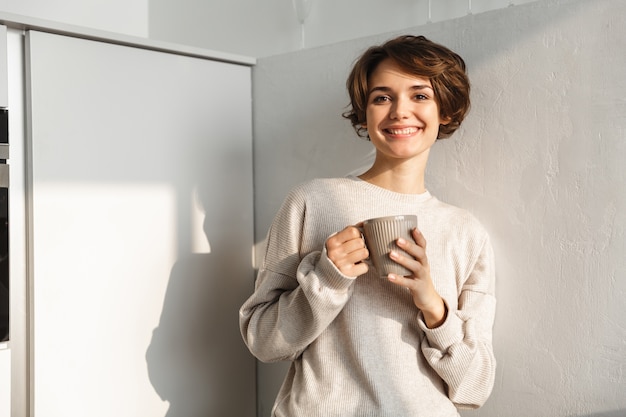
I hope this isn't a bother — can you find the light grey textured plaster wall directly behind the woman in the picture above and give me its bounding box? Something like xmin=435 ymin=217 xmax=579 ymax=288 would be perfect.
xmin=253 ymin=0 xmax=626 ymax=417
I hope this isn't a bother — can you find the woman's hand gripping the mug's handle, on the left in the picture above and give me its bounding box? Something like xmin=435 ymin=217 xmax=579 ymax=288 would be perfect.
xmin=326 ymin=224 xmax=369 ymax=277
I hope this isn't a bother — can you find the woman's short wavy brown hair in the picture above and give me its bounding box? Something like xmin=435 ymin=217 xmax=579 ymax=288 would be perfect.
xmin=343 ymin=35 xmax=470 ymax=139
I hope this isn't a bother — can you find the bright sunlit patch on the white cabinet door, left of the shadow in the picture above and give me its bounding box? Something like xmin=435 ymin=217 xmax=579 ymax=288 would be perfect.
xmin=32 ymin=183 xmax=177 ymax=415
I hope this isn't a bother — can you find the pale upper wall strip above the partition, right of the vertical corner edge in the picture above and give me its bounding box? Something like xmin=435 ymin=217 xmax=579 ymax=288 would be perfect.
xmin=150 ymin=0 xmax=533 ymax=57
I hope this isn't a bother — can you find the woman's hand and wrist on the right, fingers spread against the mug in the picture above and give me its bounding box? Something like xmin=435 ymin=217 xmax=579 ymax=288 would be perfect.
xmin=387 ymin=228 xmax=448 ymax=329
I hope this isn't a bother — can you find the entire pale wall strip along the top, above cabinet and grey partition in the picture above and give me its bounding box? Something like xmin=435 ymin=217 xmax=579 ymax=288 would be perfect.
xmin=0 ymin=0 xmax=535 ymax=57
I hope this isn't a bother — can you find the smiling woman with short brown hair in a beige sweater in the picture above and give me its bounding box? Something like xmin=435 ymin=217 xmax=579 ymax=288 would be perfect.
xmin=240 ymin=36 xmax=495 ymax=417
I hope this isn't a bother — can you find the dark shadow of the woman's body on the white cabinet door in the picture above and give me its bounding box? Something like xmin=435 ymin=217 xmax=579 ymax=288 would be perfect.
xmin=146 ymin=253 xmax=254 ymax=417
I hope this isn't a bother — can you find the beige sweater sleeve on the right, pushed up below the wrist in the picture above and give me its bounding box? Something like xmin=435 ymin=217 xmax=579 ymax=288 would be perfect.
xmin=419 ymin=232 xmax=496 ymax=408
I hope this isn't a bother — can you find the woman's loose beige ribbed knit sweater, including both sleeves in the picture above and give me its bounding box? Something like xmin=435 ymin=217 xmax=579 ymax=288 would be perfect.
xmin=240 ymin=177 xmax=496 ymax=417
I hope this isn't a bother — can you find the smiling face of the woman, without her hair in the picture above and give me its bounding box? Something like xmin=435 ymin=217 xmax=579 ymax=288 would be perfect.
xmin=365 ymin=59 xmax=445 ymax=161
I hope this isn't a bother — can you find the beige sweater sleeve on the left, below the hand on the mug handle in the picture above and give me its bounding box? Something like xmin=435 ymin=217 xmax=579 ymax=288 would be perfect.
xmin=239 ymin=187 xmax=354 ymax=362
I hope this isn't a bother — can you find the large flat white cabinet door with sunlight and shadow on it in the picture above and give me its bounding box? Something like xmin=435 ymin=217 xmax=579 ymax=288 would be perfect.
xmin=26 ymin=32 xmax=255 ymax=417
